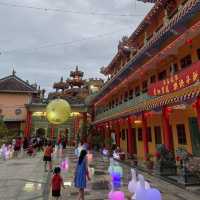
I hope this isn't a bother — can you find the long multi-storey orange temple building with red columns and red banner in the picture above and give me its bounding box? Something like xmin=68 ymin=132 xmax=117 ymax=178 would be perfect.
xmin=90 ymin=0 xmax=200 ymax=160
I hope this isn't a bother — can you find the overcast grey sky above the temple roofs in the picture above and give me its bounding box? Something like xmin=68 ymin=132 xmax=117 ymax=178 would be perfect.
xmin=0 ymin=0 xmax=152 ymax=91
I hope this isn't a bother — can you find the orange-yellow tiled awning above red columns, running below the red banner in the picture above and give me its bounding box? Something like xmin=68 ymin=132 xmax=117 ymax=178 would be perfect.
xmin=94 ymin=82 xmax=200 ymax=124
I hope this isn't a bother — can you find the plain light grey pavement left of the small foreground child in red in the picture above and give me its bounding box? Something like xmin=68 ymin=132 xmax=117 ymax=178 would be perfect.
xmin=0 ymin=153 xmax=50 ymax=200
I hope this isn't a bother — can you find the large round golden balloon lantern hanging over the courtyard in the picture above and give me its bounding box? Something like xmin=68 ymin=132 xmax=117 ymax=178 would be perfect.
xmin=46 ymin=99 xmax=71 ymax=124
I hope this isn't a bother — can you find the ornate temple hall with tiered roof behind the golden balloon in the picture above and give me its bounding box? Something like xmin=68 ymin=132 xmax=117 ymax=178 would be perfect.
xmin=27 ymin=66 xmax=104 ymax=142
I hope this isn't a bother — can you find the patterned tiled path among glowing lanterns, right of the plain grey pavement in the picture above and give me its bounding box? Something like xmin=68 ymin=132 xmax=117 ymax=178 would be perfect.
xmin=50 ymin=148 xmax=200 ymax=200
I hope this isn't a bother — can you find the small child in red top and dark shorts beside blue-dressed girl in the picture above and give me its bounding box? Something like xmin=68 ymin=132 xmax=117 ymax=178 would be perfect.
xmin=51 ymin=167 xmax=65 ymax=200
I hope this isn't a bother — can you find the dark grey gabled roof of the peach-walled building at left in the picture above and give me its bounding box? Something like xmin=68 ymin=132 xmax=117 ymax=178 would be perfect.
xmin=0 ymin=70 xmax=38 ymax=93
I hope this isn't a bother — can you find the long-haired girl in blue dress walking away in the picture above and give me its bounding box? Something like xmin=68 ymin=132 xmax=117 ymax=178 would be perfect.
xmin=74 ymin=150 xmax=90 ymax=200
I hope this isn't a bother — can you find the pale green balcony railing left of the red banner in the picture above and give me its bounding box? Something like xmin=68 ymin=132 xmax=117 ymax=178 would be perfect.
xmin=96 ymin=93 xmax=151 ymax=120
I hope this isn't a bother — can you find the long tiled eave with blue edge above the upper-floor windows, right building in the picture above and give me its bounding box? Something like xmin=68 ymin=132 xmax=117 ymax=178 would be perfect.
xmin=95 ymin=0 xmax=200 ymax=105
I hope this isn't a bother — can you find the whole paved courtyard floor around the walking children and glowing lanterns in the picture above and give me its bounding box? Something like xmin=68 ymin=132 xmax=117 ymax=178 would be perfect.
xmin=0 ymin=148 xmax=199 ymax=200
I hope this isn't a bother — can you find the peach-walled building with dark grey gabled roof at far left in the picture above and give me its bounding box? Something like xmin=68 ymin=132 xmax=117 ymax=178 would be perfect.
xmin=0 ymin=70 xmax=44 ymax=135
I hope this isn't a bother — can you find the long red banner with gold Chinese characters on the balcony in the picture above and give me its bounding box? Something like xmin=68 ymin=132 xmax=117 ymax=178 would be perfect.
xmin=148 ymin=61 xmax=200 ymax=96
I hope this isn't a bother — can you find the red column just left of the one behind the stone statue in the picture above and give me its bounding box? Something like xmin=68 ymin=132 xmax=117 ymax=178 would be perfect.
xmin=142 ymin=113 xmax=149 ymax=159
